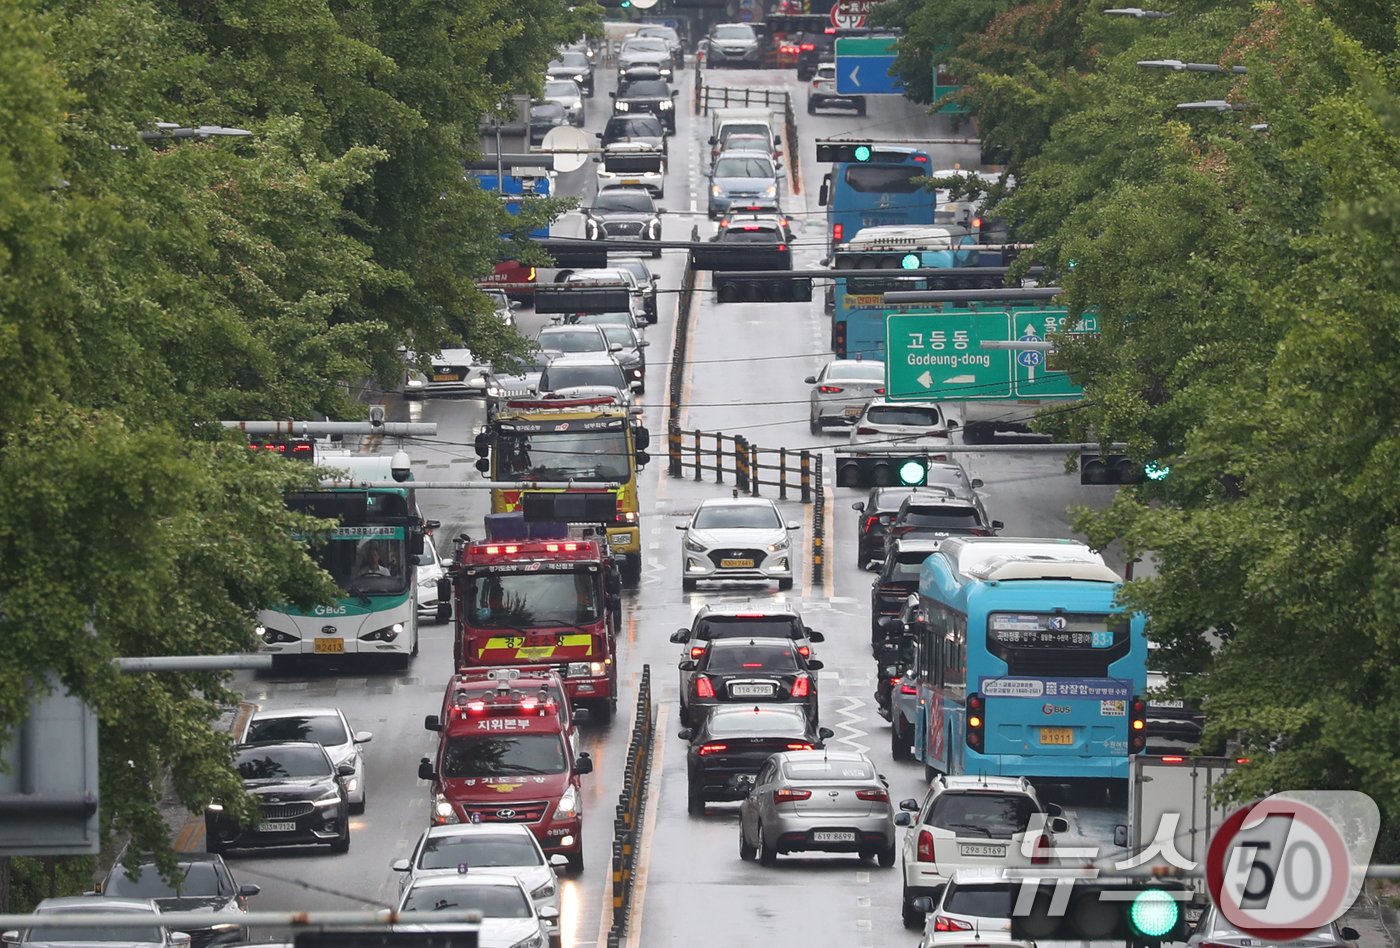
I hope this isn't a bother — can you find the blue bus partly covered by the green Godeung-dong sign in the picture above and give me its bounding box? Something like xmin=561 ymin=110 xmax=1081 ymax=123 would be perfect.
xmin=830 ymin=224 xmax=1000 ymax=360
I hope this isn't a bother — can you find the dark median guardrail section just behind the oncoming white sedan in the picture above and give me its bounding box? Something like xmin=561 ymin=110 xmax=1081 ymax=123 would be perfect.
xmin=666 ymin=424 xmax=822 ymax=504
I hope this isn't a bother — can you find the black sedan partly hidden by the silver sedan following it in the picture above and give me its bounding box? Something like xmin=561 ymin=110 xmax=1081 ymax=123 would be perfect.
xmin=676 ymin=704 xmax=832 ymax=816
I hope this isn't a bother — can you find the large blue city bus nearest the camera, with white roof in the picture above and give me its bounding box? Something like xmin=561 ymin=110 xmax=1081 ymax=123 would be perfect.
xmin=890 ymin=536 xmax=1148 ymax=795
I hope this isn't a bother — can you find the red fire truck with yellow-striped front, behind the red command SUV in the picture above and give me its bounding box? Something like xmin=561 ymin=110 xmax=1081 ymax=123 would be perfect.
xmin=451 ymin=538 xmax=622 ymax=724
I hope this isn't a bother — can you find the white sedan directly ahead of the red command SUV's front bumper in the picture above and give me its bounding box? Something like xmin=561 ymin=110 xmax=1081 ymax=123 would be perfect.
xmin=389 ymin=823 xmax=568 ymax=940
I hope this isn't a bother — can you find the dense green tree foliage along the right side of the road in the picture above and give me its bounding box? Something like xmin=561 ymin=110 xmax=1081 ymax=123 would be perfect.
xmin=909 ymin=0 xmax=1400 ymax=816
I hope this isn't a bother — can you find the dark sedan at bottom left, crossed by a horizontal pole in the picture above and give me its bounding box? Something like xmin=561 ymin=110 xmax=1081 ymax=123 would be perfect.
xmin=98 ymin=853 xmax=262 ymax=948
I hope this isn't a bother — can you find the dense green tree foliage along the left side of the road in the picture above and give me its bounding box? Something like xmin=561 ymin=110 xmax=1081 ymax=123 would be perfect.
xmin=0 ymin=0 xmax=588 ymax=909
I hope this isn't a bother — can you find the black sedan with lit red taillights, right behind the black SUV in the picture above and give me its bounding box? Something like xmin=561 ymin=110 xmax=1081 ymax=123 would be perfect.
xmin=679 ymin=637 xmax=822 ymax=727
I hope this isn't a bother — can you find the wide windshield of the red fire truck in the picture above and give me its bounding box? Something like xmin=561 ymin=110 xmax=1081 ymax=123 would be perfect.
xmin=462 ymin=571 xmax=602 ymax=629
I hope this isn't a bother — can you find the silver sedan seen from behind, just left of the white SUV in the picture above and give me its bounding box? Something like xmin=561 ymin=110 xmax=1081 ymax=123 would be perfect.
xmin=739 ymin=751 xmax=895 ymax=868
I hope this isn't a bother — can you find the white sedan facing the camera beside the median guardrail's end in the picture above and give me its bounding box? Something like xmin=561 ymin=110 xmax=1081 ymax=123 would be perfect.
xmin=676 ymin=497 xmax=801 ymax=592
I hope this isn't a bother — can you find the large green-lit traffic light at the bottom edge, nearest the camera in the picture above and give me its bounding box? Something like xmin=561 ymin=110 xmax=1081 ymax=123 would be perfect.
xmin=1011 ymin=878 xmax=1191 ymax=948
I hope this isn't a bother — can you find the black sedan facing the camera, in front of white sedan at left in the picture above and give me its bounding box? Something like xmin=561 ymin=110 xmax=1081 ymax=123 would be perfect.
xmin=204 ymin=741 xmax=354 ymax=853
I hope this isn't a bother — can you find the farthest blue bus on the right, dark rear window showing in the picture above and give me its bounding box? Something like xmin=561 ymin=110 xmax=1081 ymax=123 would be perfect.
xmin=819 ymin=144 xmax=937 ymax=255
